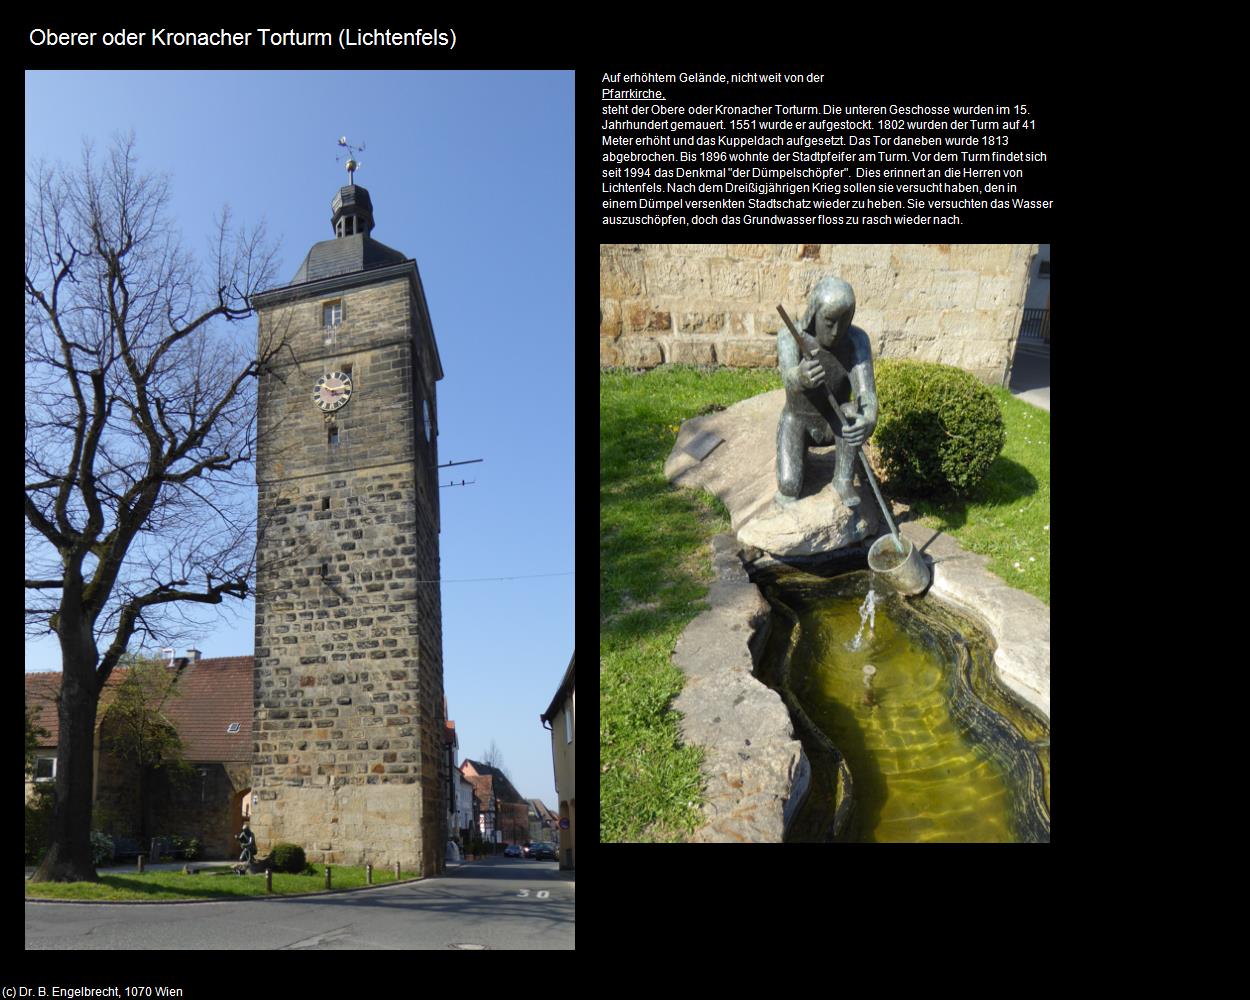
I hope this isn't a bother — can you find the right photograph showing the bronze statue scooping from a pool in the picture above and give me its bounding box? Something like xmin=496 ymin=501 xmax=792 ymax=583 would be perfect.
xmin=599 ymin=244 xmax=1050 ymax=844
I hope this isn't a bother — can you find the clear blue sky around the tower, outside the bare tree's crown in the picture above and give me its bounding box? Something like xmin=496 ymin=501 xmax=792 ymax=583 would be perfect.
xmin=25 ymin=71 xmax=575 ymax=809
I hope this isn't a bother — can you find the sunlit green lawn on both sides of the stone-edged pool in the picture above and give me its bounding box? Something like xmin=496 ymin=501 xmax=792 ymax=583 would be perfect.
xmin=599 ymin=366 xmax=1050 ymax=843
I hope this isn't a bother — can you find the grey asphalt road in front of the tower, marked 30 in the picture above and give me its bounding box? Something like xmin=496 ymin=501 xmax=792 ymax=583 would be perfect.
xmin=26 ymin=858 xmax=574 ymax=951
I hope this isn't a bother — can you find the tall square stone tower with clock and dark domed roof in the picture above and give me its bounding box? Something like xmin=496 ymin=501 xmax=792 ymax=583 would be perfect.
xmin=253 ymin=184 xmax=446 ymax=875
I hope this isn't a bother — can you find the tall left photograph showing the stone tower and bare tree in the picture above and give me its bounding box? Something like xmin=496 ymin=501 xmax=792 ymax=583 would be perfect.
xmin=25 ymin=71 xmax=576 ymax=949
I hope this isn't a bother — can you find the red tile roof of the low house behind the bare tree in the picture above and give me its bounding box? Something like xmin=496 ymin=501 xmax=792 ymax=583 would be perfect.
xmin=26 ymin=656 xmax=253 ymax=763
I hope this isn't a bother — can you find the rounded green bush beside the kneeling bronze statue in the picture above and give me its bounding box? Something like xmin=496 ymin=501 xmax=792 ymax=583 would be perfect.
xmin=873 ymin=359 xmax=1006 ymax=498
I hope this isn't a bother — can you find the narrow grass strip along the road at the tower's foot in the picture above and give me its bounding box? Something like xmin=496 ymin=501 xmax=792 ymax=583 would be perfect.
xmin=26 ymin=865 xmax=420 ymax=903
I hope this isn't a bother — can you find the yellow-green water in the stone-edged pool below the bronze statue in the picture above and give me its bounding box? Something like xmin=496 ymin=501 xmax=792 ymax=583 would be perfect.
xmin=765 ymin=573 xmax=1050 ymax=844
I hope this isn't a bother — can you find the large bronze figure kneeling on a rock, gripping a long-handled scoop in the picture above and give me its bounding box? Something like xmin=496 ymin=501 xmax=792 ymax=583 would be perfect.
xmin=776 ymin=278 xmax=876 ymax=508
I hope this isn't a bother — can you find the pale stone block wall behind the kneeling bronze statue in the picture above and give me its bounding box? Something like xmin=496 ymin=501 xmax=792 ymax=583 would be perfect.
xmin=599 ymin=244 xmax=1038 ymax=385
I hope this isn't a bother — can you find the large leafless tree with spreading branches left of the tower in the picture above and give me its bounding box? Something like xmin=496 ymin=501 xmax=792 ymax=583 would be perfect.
xmin=25 ymin=135 xmax=283 ymax=881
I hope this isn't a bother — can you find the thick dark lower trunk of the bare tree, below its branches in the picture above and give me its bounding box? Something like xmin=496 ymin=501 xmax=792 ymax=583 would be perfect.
xmin=31 ymin=658 xmax=100 ymax=883
